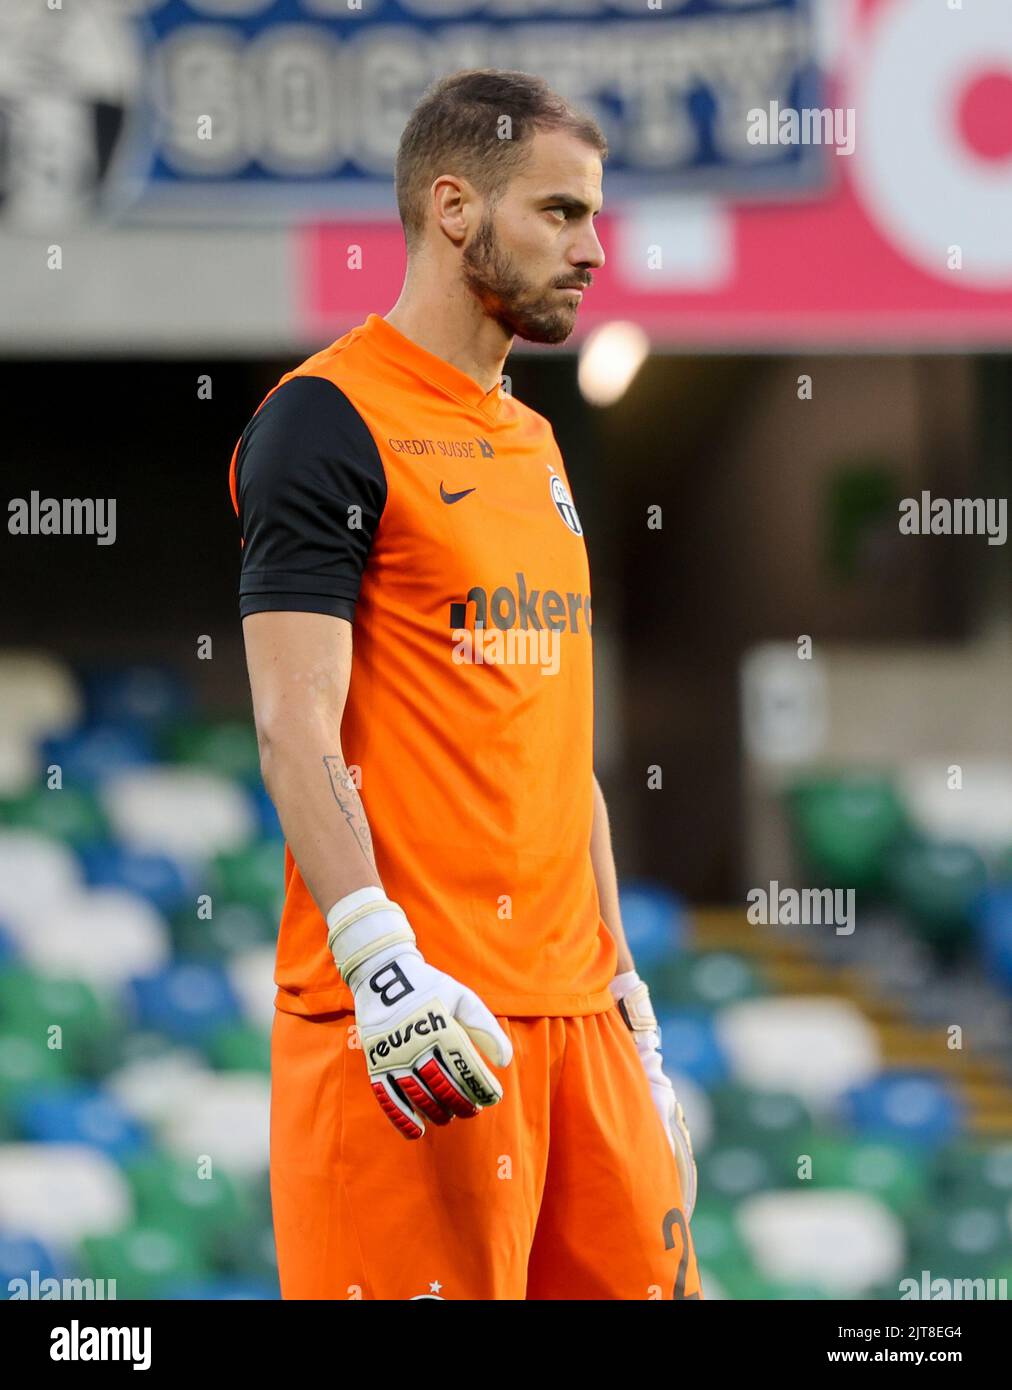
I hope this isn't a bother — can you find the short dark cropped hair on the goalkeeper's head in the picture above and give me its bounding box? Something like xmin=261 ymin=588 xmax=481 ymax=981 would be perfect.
xmin=395 ymin=68 xmax=607 ymax=252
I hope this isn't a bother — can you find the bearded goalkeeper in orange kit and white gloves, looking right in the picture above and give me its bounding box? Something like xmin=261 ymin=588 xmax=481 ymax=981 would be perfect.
xmin=231 ymin=70 xmax=702 ymax=1300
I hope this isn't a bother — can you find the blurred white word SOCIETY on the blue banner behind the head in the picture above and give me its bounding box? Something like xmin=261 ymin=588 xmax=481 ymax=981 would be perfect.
xmin=154 ymin=13 xmax=812 ymax=178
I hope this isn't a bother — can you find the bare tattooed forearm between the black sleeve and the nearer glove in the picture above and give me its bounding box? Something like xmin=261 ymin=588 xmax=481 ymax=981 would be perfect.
xmin=242 ymin=613 xmax=382 ymax=916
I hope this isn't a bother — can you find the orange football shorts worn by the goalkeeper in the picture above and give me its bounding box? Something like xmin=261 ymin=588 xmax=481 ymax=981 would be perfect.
xmin=271 ymin=1008 xmax=702 ymax=1300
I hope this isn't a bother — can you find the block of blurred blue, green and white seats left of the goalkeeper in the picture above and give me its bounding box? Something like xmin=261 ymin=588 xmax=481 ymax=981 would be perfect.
xmin=0 ymin=655 xmax=284 ymax=1298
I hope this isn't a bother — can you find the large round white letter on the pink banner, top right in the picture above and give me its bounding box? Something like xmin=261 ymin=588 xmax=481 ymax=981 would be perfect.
xmin=848 ymin=0 xmax=1012 ymax=289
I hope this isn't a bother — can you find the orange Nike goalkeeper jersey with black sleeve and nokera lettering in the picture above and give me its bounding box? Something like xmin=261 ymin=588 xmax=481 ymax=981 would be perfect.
xmin=229 ymin=314 xmax=616 ymax=1016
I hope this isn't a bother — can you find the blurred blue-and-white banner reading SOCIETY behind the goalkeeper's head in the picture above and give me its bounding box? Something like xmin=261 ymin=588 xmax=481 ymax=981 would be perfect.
xmin=0 ymin=0 xmax=824 ymax=221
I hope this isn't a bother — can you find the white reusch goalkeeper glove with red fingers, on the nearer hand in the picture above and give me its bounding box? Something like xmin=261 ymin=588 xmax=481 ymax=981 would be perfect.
xmin=327 ymin=884 xmax=513 ymax=1138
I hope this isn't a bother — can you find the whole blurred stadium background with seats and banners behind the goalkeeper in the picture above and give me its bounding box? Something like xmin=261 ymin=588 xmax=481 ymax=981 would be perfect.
xmin=0 ymin=0 xmax=1012 ymax=1298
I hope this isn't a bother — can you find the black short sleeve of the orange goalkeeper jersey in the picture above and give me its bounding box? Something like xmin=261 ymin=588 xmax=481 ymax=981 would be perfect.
xmin=235 ymin=377 xmax=386 ymax=621
